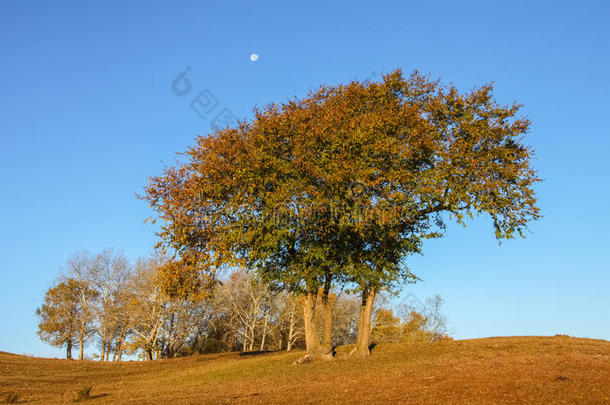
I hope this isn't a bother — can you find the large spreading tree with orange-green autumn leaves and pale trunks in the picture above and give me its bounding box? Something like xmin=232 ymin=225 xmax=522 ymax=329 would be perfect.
xmin=143 ymin=70 xmax=539 ymax=358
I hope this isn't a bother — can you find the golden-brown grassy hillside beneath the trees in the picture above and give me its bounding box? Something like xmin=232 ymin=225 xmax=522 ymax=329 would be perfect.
xmin=0 ymin=336 xmax=610 ymax=405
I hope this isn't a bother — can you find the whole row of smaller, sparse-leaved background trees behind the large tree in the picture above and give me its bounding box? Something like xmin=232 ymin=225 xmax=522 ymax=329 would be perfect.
xmin=36 ymin=249 xmax=445 ymax=361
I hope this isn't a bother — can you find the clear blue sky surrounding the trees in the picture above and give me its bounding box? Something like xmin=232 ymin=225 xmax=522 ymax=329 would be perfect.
xmin=0 ymin=1 xmax=610 ymax=356
